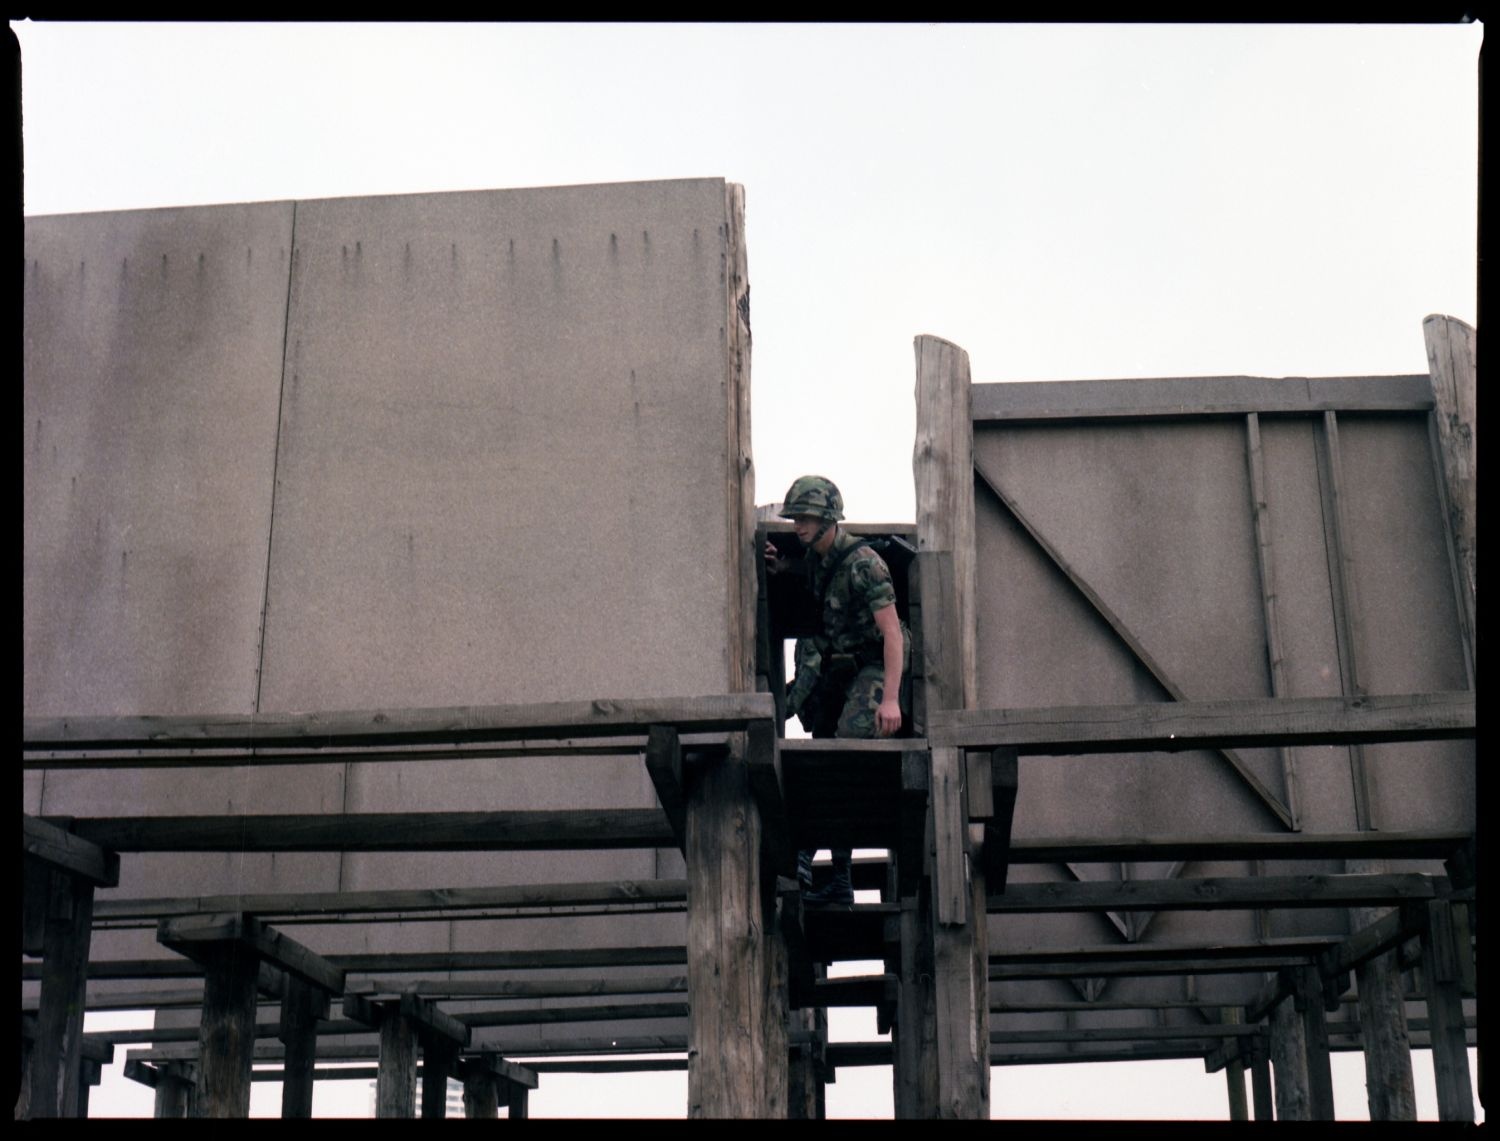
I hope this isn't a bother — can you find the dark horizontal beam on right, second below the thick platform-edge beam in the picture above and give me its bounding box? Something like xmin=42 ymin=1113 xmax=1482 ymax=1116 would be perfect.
xmin=989 ymin=873 xmax=1446 ymax=911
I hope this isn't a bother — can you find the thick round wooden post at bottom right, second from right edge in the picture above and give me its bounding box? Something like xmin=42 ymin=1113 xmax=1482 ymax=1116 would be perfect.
xmin=1344 ymin=859 xmax=1416 ymax=1122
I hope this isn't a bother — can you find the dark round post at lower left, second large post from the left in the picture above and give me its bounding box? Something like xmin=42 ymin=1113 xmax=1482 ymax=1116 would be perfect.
xmin=197 ymin=942 xmax=261 ymax=1117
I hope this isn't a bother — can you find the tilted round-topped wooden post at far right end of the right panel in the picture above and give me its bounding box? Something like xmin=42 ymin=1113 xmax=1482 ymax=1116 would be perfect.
xmin=1422 ymin=313 xmax=1479 ymax=658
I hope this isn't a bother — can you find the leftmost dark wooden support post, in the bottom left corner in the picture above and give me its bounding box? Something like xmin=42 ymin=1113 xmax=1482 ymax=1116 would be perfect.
xmin=26 ymin=871 xmax=95 ymax=1117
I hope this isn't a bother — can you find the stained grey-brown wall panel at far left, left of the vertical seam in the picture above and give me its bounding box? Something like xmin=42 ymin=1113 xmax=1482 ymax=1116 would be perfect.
xmin=23 ymin=202 xmax=293 ymax=717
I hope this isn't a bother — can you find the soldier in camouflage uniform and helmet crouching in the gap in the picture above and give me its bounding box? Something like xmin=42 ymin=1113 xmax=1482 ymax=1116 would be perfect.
xmin=765 ymin=475 xmax=911 ymax=904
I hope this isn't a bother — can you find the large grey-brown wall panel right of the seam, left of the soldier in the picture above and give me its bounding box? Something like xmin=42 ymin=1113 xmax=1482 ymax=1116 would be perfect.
xmin=263 ymin=180 xmax=729 ymax=709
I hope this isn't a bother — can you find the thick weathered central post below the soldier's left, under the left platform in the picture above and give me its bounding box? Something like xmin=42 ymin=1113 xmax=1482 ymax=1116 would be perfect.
xmin=686 ymin=733 xmax=783 ymax=1117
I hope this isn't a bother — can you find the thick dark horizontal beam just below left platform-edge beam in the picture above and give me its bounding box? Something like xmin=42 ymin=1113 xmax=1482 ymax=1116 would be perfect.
xmin=75 ymin=808 xmax=675 ymax=852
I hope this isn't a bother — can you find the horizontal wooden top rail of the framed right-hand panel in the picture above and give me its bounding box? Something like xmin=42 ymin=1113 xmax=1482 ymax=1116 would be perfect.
xmin=974 ymin=376 xmax=1433 ymax=423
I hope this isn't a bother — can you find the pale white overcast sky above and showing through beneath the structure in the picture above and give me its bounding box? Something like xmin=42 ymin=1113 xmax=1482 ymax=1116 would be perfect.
xmin=20 ymin=24 xmax=1484 ymax=1117
